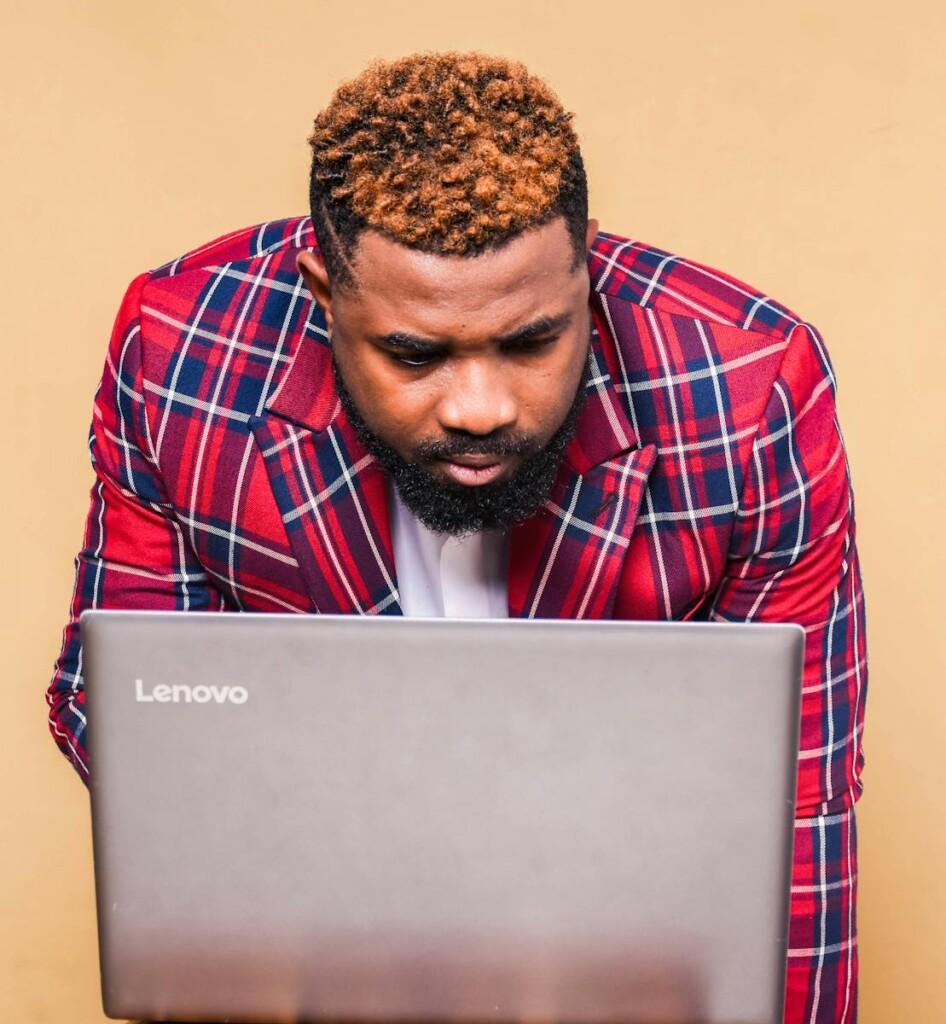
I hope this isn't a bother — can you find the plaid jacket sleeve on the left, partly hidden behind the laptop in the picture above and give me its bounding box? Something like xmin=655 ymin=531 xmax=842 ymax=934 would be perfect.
xmin=46 ymin=274 xmax=223 ymax=781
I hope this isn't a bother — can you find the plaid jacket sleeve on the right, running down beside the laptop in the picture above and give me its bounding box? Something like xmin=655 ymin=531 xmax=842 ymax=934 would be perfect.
xmin=711 ymin=324 xmax=867 ymax=1024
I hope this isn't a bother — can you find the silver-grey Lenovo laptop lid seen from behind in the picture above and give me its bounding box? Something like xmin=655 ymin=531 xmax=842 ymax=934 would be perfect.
xmin=81 ymin=611 xmax=804 ymax=1024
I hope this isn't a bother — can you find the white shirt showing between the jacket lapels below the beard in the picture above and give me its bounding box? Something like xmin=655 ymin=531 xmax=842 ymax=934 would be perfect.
xmin=388 ymin=480 xmax=509 ymax=618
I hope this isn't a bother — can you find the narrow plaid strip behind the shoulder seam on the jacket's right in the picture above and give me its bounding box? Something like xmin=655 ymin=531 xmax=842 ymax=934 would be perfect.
xmin=589 ymin=231 xmax=802 ymax=338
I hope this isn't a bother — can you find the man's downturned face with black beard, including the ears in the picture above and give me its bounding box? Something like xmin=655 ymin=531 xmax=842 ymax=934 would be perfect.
xmin=299 ymin=218 xmax=597 ymax=534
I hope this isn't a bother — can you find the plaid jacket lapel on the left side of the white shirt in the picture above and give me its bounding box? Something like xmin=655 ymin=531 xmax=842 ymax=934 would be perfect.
xmin=250 ymin=315 xmax=400 ymax=614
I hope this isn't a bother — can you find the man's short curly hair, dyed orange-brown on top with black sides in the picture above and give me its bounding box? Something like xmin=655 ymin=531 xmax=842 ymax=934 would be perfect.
xmin=309 ymin=52 xmax=588 ymax=287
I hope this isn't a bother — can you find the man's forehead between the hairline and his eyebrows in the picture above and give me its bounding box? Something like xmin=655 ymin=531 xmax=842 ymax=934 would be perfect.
xmin=334 ymin=218 xmax=587 ymax=338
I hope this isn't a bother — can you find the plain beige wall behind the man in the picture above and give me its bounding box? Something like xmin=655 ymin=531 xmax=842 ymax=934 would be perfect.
xmin=0 ymin=0 xmax=946 ymax=1024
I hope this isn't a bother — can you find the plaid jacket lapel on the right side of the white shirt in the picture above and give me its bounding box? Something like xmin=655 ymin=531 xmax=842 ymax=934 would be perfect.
xmin=509 ymin=308 xmax=657 ymax=618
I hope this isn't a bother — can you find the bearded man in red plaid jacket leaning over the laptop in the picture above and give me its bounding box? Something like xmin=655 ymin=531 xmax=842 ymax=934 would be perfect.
xmin=48 ymin=54 xmax=866 ymax=1022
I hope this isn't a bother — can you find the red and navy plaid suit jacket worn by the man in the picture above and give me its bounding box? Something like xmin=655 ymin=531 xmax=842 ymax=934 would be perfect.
xmin=48 ymin=218 xmax=866 ymax=1024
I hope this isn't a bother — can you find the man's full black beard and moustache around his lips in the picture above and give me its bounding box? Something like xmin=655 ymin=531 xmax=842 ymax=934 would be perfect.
xmin=332 ymin=352 xmax=590 ymax=536
